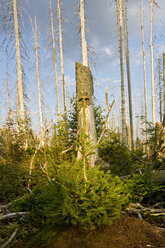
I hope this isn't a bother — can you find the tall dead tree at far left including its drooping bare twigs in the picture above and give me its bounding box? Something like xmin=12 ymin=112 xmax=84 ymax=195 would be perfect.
xmin=1 ymin=0 xmax=25 ymax=126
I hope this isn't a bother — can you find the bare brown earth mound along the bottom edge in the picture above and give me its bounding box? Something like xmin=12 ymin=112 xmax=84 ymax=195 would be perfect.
xmin=11 ymin=214 xmax=165 ymax=248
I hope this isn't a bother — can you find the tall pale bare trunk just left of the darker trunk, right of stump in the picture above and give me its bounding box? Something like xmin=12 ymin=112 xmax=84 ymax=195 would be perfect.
xmin=117 ymin=0 xmax=127 ymax=144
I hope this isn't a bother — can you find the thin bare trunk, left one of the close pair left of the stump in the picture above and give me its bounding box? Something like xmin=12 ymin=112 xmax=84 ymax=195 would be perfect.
xmin=49 ymin=0 xmax=60 ymax=116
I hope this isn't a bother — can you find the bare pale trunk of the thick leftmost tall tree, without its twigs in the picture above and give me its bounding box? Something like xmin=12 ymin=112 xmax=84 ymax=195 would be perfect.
xmin=12 ymin=0 xmax=25 ymax=123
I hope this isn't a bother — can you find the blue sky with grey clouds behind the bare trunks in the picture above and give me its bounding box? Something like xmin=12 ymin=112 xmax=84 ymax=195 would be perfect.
xmin=0 ymin=0 xmax=165 ymax=136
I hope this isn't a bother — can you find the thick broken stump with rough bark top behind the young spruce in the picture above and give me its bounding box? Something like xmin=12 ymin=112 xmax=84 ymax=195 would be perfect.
xmin=76 ymin=63 xmax=98 ymax=168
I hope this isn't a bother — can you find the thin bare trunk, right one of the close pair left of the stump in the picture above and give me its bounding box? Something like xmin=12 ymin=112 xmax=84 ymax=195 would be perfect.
xmin=57 ymin=0 xmax=66 ymax=113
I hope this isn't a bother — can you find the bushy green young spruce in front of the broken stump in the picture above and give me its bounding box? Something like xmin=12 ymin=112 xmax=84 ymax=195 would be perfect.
xmin=15 ymin=162 xmax=128 ymax=229
